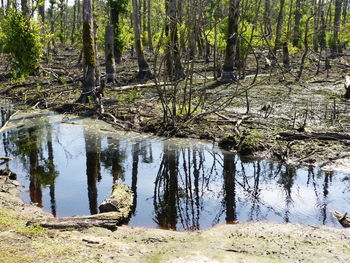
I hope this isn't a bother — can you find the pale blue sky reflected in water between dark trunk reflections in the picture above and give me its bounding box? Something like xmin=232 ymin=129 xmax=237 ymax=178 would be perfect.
xmin=0 ymin=109 xmax=350 ymax=229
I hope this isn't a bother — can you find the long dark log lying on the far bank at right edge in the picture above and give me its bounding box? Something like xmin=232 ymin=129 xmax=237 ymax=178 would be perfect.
xmin=278 ymin=132 xmax=350 ymax=141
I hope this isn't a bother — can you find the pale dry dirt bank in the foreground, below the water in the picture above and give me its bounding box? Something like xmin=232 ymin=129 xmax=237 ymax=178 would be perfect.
xmin=0 ymin=174 xmax=350 ymax=263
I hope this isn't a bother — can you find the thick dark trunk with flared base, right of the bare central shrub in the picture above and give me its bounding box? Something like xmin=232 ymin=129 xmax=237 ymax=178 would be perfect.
xmin=221 ymin=0 xmax=240 ymax=82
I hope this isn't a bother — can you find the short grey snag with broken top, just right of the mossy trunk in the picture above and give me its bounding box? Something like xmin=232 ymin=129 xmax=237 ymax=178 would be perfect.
xmin=105 ymin=25 xmax=115 ymax=83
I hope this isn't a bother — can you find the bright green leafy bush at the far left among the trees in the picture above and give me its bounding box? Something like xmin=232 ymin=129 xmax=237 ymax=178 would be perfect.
xmin=0 ymin=9 xmax=43 ymax=78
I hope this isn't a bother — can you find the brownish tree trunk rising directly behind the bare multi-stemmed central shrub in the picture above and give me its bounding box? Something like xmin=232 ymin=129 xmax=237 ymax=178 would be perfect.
xmin=165 ymin=0 xmax=185 ymax=79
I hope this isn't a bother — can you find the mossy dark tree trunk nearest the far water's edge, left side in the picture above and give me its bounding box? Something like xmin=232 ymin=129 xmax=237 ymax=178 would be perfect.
xmin=78 ymin=0 xmax=96 ymax=103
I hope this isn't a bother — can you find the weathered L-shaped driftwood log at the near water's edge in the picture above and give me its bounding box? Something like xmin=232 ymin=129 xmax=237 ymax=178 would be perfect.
xmin=27 ymin=182 xmax=133 ymax=230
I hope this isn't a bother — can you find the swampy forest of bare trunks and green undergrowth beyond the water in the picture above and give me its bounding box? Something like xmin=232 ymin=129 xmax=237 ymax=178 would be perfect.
xmin=0 ymin=0 xmax=350 ymax=159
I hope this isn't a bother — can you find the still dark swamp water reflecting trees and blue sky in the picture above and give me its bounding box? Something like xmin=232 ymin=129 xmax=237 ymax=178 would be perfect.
xmin=0 ymin=104 xmax=350 ymax=230
